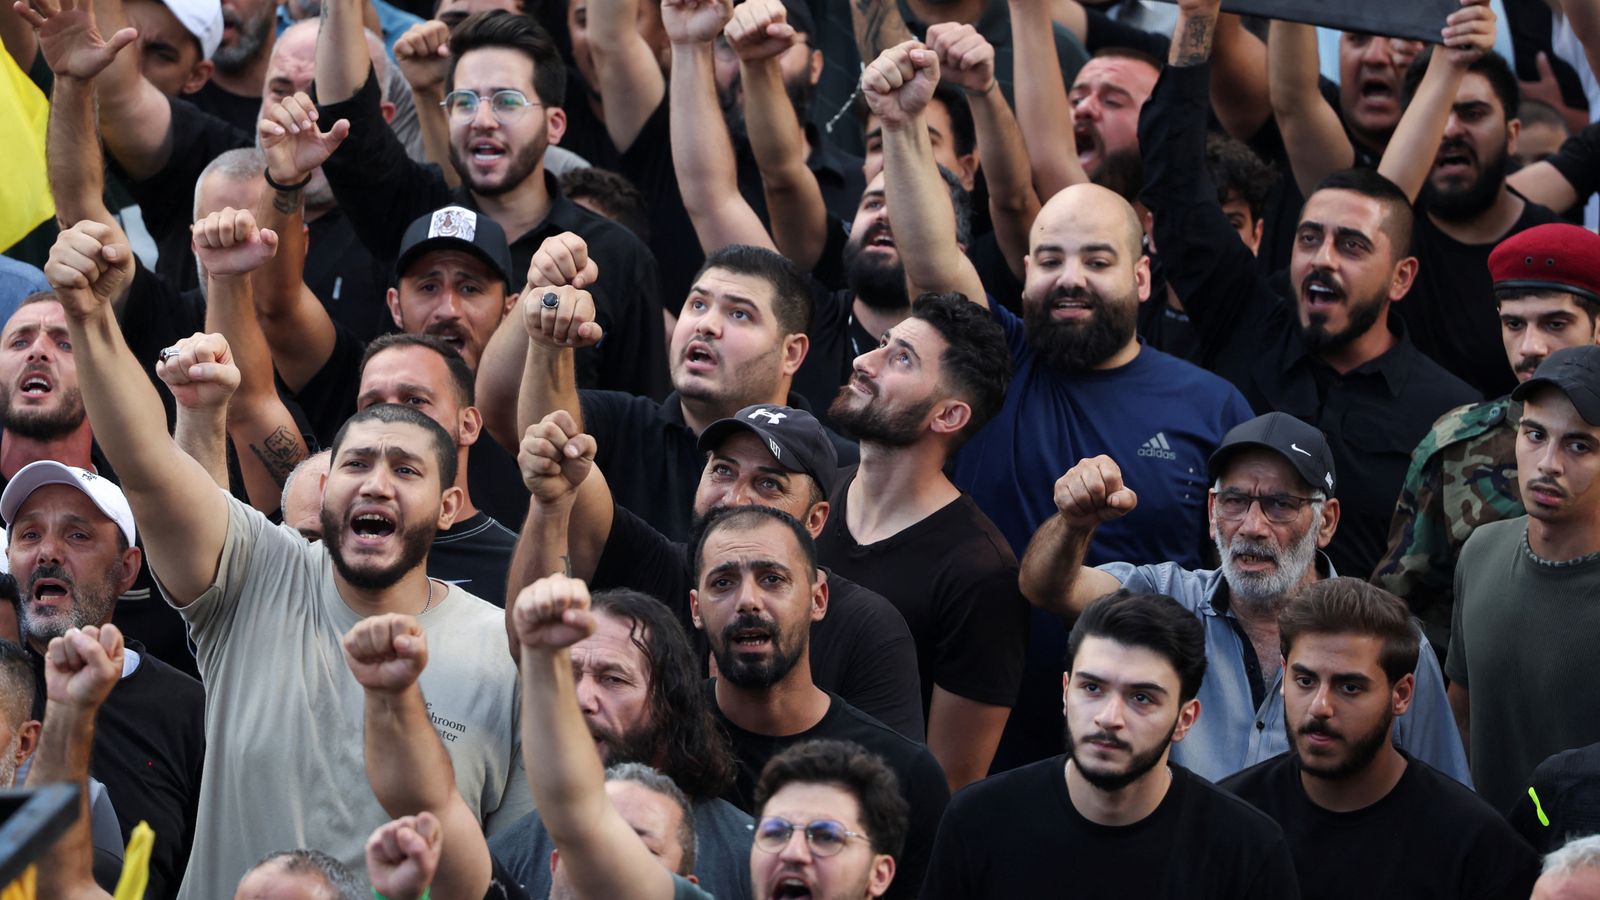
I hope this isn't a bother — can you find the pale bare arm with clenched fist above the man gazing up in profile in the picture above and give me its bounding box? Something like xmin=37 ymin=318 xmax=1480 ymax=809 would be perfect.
xmin=861 ymin=40 xmax=989 ymax=301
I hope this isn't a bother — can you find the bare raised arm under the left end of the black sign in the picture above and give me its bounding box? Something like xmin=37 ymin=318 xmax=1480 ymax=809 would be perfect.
xmin=1267 ymin=21 xmax=1356 ymax=195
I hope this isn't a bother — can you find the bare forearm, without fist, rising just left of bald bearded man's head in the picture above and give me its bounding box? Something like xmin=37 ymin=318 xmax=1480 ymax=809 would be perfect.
xmin=970 ymin=82 xmax=1040 ymax=279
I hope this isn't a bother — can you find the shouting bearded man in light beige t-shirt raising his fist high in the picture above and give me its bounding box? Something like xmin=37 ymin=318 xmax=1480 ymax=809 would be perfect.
xmin=45 ymin=212 xmax=530 ymax=897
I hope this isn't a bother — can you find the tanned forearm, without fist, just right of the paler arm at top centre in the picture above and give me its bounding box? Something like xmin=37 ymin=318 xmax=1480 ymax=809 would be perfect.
xmin=741 ymin=59 xmax=827 ymax=265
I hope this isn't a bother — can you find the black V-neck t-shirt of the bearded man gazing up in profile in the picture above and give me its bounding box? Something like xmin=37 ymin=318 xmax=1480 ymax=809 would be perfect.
xmin=816 ymin=472 xmax=1029 ymax=713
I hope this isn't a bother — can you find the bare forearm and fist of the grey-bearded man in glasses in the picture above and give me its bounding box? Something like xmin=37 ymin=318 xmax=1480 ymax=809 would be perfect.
xmin=1018 ymin=456 xmax=1139 ymax=617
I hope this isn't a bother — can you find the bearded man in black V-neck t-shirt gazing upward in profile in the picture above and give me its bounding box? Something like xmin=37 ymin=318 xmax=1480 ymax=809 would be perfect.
xmin=818 ymin=295 xmax=1029 ymax=788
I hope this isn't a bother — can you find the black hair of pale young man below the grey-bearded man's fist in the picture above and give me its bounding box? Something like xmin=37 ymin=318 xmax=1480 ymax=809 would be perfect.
xmin=1067 ymin=589 xmax=1205 ymax=703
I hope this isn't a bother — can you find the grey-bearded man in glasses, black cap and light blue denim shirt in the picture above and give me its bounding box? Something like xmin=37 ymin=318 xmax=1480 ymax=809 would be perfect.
xmin=1021 ymin=413 xmax=1467 ymax=783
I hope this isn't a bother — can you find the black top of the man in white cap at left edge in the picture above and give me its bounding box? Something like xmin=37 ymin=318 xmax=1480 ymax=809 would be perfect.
xmin=30 ymin=641 xmax=205 ymax=900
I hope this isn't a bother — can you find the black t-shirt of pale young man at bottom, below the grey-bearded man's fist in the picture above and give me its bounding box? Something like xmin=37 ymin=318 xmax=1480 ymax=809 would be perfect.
xmin=922 ymin=754 xmax=1299 ymax=900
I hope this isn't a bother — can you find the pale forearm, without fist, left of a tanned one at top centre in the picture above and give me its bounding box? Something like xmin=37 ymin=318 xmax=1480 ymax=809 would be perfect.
xmin=669 ymin=43 xmax=771 ymax=253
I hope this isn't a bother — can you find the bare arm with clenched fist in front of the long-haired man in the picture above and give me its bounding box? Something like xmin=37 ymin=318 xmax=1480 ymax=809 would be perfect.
xmin=507 ymin=575 xmax=675 ymax=900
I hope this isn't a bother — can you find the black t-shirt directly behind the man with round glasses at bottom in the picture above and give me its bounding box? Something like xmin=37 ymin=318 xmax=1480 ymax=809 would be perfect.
xmin=706 ymin=679 xmax=950 ymax=900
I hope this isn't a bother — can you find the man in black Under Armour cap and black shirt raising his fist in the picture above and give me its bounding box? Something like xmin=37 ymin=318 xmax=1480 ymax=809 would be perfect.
xmin=509 ymin=405 xmax=923 ymax=741
